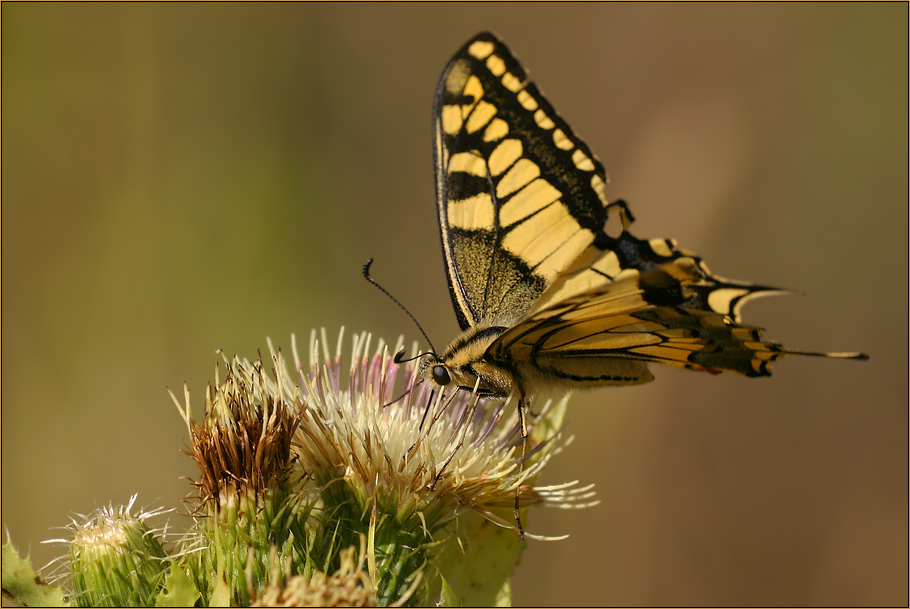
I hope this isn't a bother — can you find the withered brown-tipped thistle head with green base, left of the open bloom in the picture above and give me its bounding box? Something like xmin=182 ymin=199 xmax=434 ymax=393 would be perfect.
xmin=174 ymin=357 xmax=320 ymax=606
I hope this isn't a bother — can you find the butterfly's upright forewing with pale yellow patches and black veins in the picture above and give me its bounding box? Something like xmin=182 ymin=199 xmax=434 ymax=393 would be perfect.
xmin=433 ymin=33 xmax=607 ymax=329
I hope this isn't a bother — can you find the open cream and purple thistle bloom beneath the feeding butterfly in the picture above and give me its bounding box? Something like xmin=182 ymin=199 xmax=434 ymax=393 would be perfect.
xmin=284 ymin=332 xmax=593 ymax=535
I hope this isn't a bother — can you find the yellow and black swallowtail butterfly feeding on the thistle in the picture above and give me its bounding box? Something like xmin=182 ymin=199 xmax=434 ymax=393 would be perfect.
xmin=418 ymin=33 xmax=867 ymax=422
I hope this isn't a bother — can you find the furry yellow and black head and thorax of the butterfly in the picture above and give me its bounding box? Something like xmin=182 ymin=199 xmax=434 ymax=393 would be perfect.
xmin=419 ymin=324 xmax=516 ymax=398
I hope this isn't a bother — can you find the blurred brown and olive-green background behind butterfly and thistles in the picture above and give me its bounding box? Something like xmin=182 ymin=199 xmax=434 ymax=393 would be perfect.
xmin=0 ymin=3 xmax=908 ymax=605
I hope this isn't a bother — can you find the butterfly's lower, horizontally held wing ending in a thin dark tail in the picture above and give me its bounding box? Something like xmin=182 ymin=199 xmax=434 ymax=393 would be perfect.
xmin=486 ymin=256 xmax=865 ymax=386
